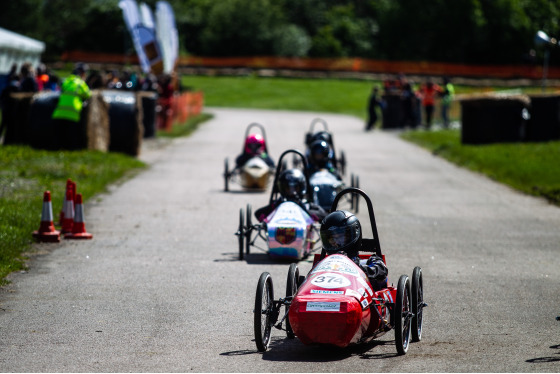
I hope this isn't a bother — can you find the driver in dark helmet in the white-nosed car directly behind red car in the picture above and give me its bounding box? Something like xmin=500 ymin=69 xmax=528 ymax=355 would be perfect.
xmin=255 ymin=169 xmax=327 ymax=222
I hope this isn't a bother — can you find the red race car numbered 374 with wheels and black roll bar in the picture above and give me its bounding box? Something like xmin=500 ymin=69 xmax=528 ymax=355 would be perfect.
xmin=254 ymin=188 xmax=427 ymax=355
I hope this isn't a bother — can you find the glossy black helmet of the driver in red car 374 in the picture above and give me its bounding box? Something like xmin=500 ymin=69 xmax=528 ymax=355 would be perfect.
xmin=321 ymin=210 xmax=362 ymax=257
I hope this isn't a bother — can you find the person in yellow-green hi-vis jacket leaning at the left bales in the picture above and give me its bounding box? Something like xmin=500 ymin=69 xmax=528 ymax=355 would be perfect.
xmin=52 ymin=63 xmax=91 ymax=150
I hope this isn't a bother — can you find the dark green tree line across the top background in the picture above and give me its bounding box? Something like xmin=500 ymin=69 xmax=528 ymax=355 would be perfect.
xmin=0 ymin=0 xmax=560 ymax=65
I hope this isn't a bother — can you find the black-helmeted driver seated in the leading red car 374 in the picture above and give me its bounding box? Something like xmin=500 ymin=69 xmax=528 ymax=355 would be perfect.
xmin=321 ymin=210 xmax=389 ymax=290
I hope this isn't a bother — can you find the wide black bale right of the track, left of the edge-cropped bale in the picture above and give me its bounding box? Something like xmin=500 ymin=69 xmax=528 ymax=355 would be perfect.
xmin=460 ymin=94 xmax=531 ymax=144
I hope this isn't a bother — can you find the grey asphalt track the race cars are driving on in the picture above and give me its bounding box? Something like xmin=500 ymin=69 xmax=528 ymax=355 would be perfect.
xmin=0 ymin=109 xmax=560 ymax=372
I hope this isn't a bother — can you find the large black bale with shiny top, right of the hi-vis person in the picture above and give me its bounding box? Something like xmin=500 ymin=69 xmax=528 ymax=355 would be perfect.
xmin=102 ymin=90 xmax=144 ymax=156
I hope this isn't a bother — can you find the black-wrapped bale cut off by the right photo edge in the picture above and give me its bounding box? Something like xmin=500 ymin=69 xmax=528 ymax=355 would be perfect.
xmin=526 ymin=94 xmax=560 ymax=142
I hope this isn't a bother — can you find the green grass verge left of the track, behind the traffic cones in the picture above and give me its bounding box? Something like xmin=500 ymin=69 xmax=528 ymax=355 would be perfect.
xmin=0 ymin=146 xmax=145 ymax=284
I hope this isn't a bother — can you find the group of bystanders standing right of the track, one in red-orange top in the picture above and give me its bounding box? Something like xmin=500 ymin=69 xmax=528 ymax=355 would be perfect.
xmin=366 ymin=74 xmax=455 ymax=131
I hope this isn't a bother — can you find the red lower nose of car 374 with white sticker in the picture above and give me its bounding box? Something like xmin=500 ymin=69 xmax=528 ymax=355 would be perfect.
xmin=289 ymin=296 xmax=370 ymax=348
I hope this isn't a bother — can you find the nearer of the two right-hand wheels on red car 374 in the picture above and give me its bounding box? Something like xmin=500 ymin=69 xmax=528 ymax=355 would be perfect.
xmin=393 ymin=275 xmax=411 ymax=355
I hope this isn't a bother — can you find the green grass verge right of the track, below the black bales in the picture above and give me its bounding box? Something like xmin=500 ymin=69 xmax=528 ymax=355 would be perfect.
xmin=402 ymin=130 xmax=560 ymax=206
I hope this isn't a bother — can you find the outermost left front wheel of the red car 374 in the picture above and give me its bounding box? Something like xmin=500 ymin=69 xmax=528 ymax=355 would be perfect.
xmin=253 ymin=272 xmax=274 ymax=352
